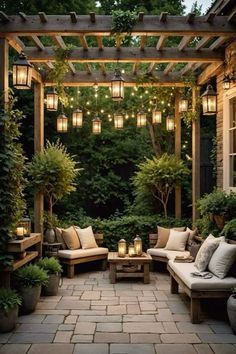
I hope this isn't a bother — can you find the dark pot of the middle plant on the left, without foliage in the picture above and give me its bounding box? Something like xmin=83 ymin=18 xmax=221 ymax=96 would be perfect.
xmin=20 ymin=285 xmax=41 ymax=315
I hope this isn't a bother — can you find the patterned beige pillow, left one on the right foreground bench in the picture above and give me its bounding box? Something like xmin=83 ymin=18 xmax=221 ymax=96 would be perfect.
xmin=195 ymin=235 xmax=225 ymax=272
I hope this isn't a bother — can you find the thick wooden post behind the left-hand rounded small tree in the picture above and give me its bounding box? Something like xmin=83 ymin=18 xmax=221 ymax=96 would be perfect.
xmin=34 ymin=82 xmax=44 ymax=234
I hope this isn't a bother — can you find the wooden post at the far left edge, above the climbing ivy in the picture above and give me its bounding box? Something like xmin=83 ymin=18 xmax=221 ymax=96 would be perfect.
xmin=0 ymin=38 xmax=9 ymax=109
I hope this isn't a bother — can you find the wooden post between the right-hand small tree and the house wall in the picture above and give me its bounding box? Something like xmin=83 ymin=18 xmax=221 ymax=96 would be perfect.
xmin=192 ymin=87 xmax=200 ymax=222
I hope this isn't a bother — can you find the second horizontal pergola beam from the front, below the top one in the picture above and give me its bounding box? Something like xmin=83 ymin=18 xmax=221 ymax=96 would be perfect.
xmin=25 ymin=47 xmax=224 ymax=63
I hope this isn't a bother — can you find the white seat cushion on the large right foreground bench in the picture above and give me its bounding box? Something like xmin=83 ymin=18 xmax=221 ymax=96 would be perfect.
xmin=168 ymin=260 xmax=236 ymax=291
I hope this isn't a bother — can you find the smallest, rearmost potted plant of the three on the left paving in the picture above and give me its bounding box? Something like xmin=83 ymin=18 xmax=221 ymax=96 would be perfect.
xmin=38 ymin=257 xmax=62 ymax=296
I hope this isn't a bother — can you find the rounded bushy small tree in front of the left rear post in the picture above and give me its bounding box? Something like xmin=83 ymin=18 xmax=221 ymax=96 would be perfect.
xmin=28 ymin=140 xmax=81 ymax=223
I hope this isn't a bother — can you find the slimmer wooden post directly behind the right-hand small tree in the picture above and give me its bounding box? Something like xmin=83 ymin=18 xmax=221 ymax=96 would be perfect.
xmin=175 ymin=92 xmax=181 ymax=219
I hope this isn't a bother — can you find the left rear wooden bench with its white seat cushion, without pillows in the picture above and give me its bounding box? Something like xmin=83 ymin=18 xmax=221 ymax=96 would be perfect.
xmin=58 ymin=234 xmax=108 ymax=278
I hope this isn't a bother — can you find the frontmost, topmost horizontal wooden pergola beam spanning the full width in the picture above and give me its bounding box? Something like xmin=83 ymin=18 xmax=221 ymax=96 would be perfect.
xmin=0 ymin=12 xmax=235 ymax=37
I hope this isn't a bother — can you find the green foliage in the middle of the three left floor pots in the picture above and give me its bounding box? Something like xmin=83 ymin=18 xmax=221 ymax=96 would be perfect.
xmin=15 ymin=264 xmax=48 ymax=288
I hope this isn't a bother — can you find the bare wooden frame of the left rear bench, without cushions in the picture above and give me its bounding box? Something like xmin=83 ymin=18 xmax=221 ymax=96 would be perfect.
xmin=59 ymin=234 xmax=107 ymax=278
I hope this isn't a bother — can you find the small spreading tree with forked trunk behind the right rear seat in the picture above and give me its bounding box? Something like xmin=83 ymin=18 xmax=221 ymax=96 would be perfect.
xmin=133 ymin=154 xmax=189 ymax=218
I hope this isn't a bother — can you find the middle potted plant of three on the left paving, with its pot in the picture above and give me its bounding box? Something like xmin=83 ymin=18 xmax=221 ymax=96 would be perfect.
xmin=15 ymin=264 xmax=48 ymax=314
